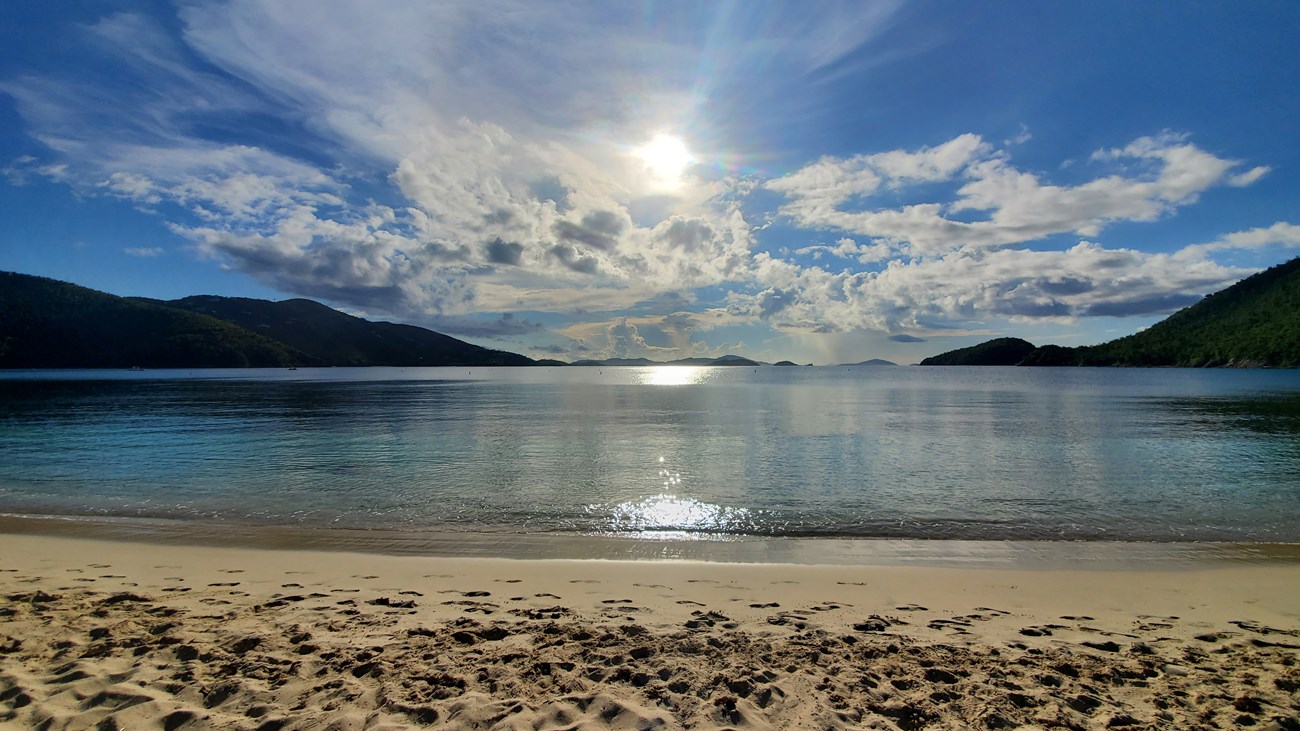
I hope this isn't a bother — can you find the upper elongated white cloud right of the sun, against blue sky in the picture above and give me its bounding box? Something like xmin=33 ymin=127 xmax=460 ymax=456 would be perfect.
xmin=767 ymin=133 xmax=1268 ymax=255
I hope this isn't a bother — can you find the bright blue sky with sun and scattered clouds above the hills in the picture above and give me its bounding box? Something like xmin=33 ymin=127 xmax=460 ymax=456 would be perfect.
xmin=0 ymin=0 xmax=1300 ymax=364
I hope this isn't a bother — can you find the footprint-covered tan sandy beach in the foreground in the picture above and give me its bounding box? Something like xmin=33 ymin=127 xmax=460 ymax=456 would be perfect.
xmin=0 ymin=535 xmax=1300 ymax=730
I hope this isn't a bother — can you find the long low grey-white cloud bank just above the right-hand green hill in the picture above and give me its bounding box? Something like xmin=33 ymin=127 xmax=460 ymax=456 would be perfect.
xmin=732 ymin=242 xmax=1249 ymax=333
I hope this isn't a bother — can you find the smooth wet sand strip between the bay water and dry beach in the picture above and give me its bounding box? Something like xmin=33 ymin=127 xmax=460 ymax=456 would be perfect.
xmin=0 ymin=514 xmax=1300 ymax=570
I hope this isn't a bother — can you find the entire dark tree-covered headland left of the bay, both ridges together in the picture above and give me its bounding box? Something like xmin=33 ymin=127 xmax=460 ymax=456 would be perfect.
xmin=0 ymin=272 xmax=533 ymax=368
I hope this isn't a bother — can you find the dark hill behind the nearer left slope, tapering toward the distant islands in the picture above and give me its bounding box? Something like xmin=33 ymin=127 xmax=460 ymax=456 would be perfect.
xmin=160 ymin=295 xmax=533 ymax=366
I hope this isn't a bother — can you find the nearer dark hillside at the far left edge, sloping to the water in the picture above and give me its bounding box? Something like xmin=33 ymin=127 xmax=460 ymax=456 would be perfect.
xmin=0 ymin=272 xmax=306 ymax=368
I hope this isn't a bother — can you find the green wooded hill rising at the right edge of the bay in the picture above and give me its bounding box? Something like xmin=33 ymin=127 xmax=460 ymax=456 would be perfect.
xmin=920 ymin=258 xmax=1300 ymax=368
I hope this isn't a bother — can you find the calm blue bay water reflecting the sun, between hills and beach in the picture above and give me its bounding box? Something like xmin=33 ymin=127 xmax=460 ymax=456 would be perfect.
xmin=0 ymin=367 xmax=1300 ymax=542
